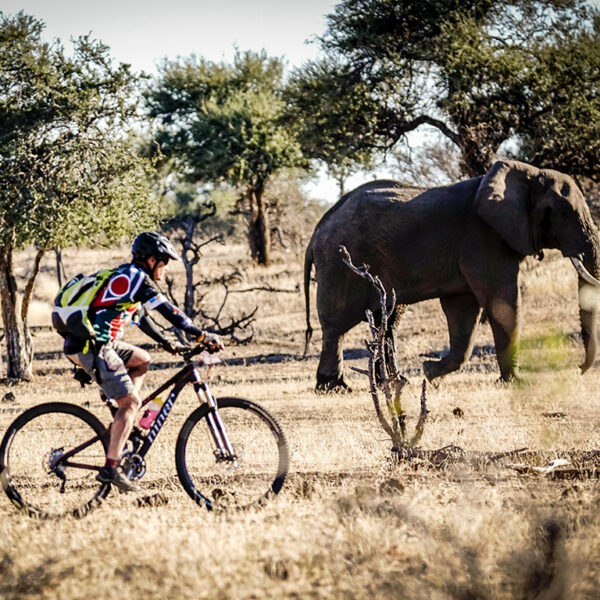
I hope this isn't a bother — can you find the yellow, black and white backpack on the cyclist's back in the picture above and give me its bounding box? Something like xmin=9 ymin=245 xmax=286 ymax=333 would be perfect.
xmin=52 ymin=269 xmax=114 ymax=340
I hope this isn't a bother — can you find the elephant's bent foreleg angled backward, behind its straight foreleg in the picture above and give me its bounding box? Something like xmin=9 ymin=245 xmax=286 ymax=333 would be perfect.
xmin=423 ymin=293 xmax=481 ymax=381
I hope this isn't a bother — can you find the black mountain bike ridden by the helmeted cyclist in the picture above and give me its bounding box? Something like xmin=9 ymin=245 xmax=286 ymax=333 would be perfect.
xmin=0 ymin=345 xmax=288 ymax=518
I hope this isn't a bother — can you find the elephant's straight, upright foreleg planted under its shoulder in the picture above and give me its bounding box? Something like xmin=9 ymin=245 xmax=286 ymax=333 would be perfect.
xmin=486 ymin=287 xmax=519 ymax=381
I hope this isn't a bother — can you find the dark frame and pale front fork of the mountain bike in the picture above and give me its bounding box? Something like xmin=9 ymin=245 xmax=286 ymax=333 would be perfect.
xmin=49 ymin=351 xmax=237 ymax=471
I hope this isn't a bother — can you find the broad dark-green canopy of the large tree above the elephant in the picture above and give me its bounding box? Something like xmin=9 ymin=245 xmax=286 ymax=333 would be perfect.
xmin=293 ymin=0 xmax=600 ymax=175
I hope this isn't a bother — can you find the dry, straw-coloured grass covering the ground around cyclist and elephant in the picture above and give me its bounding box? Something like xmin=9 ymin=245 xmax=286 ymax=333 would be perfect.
xmin=0 ymin=243 xmax=600 ymax=599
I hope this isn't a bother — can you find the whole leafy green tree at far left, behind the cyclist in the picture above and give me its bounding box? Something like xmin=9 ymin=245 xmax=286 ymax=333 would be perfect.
xmin=0 ymin=12 xmax=157 ymax=379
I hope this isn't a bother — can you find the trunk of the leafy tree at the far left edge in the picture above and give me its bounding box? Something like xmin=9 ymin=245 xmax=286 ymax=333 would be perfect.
xmin=0 ymin=247 xmax=34 ymax=381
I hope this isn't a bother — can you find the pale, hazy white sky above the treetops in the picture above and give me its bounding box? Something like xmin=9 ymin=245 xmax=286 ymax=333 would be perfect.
xmin=0 ymin=0 xmax=356 ymax=202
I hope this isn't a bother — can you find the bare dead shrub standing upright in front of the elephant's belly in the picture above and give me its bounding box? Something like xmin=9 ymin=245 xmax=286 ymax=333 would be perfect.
xmin=339 ymin=246 xmax=428 ymax=448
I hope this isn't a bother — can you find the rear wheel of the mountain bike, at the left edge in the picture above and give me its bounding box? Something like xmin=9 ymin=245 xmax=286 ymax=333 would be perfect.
xmin=0 ymin=402 xmax=110 ymax=519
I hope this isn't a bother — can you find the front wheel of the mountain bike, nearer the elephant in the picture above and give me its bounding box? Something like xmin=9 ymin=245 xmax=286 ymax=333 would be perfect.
xmin=175 ymin=398 xmax=289 ymax=510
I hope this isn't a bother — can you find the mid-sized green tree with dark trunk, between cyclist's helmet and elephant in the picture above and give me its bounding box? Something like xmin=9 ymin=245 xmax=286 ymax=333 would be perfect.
xmin=146 ymin=52 xmax=305 ymax=265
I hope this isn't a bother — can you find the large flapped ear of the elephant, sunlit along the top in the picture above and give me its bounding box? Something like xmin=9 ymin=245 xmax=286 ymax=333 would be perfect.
xmin=475 ymin=161 xmax=537 ymax=255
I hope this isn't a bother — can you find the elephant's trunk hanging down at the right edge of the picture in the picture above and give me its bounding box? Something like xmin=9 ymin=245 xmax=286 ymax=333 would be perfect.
xmin=571 ymin=252 xmax=600 ymax=373
